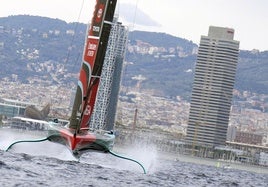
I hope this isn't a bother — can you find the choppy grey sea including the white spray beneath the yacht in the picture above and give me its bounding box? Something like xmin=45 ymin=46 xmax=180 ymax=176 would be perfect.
xmin=0 ymin=130 xmax=268 ymax=187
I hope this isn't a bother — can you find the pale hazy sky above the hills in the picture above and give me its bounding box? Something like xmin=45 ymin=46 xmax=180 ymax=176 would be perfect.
xmin=0 ymin=0 xmax=268 ymax=51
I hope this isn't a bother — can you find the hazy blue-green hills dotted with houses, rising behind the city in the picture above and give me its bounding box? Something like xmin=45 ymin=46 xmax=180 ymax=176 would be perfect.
xmin=0 ymin=15 xmax=268 ymax=99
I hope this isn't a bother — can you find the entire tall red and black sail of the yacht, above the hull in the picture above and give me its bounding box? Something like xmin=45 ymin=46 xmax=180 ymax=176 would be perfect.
xmin=69 ymin=0 xmax=116 ymax=132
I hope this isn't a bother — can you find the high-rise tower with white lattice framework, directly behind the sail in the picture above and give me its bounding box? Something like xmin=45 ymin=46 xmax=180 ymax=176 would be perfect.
xmin=90 ymin=17 xmax=128 ymax=130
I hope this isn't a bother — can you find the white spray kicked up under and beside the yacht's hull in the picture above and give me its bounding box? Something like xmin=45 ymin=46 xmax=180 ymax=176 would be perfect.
xmin=0 ymin=129 xmax=158 ymax=173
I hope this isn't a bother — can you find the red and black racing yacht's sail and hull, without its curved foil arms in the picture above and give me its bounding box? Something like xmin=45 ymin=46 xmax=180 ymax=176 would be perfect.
xmin=47 ymin=0 xmax=116 ymax=158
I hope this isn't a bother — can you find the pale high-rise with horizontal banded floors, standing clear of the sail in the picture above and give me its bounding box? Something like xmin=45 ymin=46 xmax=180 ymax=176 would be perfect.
xmin=186 ymin=26 xmax=239 ymax=147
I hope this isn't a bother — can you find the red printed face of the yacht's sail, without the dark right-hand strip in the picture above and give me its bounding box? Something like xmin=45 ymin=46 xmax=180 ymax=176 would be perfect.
xmin=69 ymin=0 xmax=107 ymax=130
